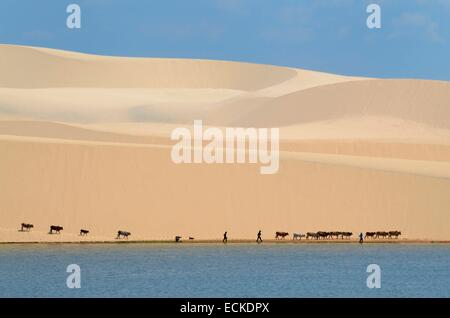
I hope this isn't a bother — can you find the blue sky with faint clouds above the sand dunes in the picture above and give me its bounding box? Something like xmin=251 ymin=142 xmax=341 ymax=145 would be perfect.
xmin=0 ymin=0 xmax=450 ymax=80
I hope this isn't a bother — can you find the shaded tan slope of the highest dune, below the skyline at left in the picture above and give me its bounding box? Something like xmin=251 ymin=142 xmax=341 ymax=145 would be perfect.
xmin=0 ymin=45 xmax=297 ymax=91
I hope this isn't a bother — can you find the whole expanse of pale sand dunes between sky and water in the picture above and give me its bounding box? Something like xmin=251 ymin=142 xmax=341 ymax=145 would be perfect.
xmin=0 ymin=45 xmax=450 ymax=242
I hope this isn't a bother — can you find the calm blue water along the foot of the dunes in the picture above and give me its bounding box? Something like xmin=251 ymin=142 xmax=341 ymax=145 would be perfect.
xmin=0 ymin=244 xmax=450 ymax=297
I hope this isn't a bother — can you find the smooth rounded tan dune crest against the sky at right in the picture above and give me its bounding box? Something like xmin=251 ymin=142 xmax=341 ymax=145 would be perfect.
xmin=230 ymin=80 xmax=450 ymax=129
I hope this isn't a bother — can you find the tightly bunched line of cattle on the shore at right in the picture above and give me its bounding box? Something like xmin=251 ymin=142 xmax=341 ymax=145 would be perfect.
xmin=275 ymin=231 xmax=402 ymax=240
